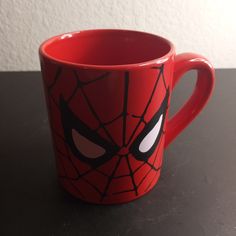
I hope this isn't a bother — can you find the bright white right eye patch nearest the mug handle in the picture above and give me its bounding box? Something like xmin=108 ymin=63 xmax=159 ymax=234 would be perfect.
xmin=139 ymin=114 xmax=163 ymax=153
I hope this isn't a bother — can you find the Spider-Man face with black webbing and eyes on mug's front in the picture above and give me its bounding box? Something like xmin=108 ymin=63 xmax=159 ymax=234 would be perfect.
xmin=45 ymin=62 xmax=169 ymax=204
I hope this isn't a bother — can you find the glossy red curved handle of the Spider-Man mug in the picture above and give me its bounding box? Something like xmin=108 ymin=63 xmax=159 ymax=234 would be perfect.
xmin=165 ymin=53 xmax=215 ymax=147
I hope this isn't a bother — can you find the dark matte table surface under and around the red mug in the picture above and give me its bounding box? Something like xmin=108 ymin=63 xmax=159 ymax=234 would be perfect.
xmin=0 ymin=69 xmax=236 ymax=236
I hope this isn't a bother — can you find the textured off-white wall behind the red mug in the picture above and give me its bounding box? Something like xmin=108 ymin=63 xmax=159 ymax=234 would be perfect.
xmin=0 ymin=0 xmax=236 ymax=70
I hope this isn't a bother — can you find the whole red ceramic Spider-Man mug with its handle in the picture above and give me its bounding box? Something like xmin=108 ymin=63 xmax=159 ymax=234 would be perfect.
xmin=39 ymin=29 xmax=215 ymax=204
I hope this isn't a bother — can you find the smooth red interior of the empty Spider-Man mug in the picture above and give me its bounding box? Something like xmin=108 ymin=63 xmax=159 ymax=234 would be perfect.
xmin=40 ymin=30 xmax=171 ymax=66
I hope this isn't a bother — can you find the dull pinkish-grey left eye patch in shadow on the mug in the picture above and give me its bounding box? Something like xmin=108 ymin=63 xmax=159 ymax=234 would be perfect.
xmin=72 ymin=129 xmax=106 ymax=158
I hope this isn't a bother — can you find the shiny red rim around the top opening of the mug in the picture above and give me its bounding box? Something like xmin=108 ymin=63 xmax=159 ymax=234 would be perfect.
xmin=39 ymin=29 xmax=175 ymax=70
